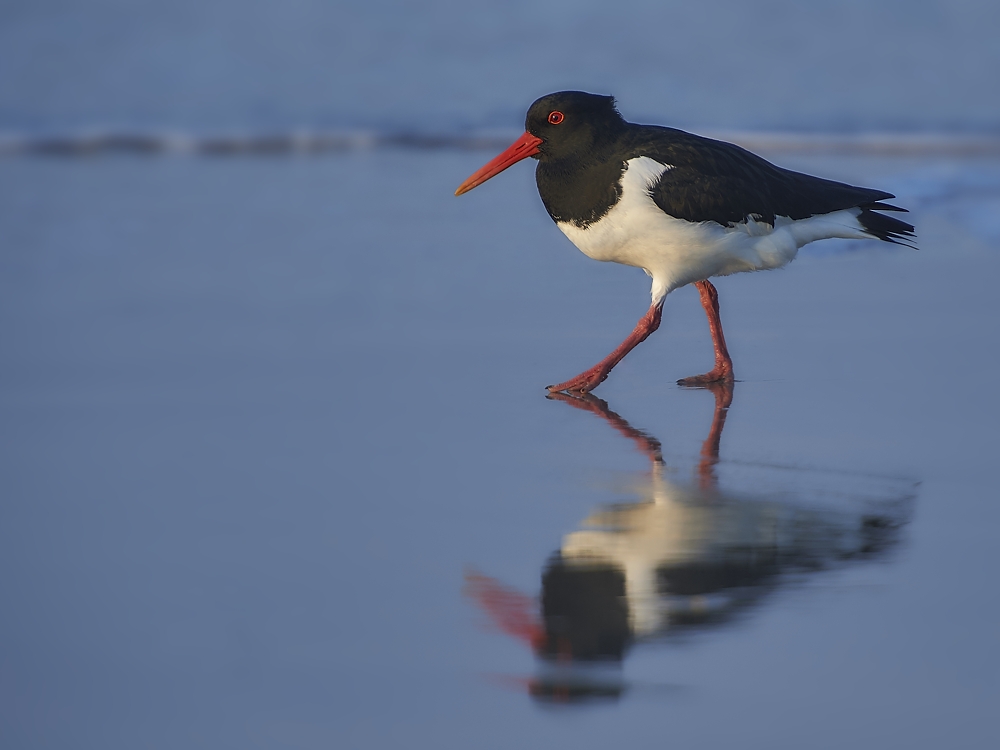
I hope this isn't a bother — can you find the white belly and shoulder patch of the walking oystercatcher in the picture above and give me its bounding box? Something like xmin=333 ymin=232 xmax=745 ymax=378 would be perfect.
xmin=557 ymin=156 xmax=869 ymax=302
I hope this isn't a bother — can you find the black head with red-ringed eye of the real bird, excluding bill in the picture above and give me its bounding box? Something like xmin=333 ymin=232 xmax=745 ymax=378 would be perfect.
xmin=524 ymin=91 xmax=626 ymax=161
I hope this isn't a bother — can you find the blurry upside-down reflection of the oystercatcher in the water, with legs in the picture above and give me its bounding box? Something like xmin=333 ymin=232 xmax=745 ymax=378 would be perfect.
xmin=466 ymin=383 xmax=914 ymax=702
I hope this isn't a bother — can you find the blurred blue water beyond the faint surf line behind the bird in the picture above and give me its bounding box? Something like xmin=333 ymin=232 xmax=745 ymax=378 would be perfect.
xmin=0 ymin=0 xmax=1000 ymax=134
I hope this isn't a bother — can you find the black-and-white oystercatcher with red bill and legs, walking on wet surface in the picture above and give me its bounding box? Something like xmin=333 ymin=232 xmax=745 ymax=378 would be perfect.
xmin=455 ymin=91 xmax=914 ymax=393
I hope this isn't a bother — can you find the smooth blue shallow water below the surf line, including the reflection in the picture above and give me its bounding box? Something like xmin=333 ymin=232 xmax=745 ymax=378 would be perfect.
xmin=0 ymin=145 xmax=1000 ymax=748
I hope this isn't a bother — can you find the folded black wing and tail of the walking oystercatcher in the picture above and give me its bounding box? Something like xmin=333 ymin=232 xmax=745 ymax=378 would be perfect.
xmin=630 ymin=126 xmax=913 ymax=242
